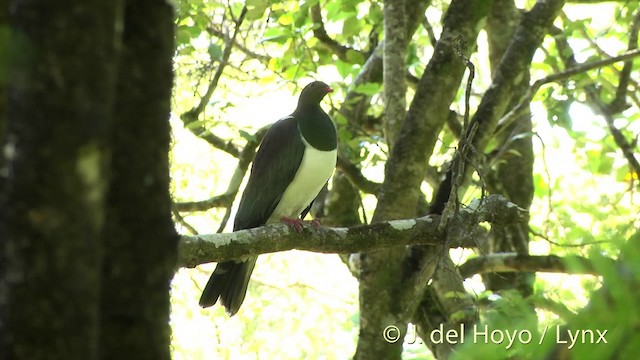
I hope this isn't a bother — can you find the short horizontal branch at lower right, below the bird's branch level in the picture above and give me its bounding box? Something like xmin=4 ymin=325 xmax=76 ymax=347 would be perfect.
xmin=459 ymin=253 xmax=613 ymax=278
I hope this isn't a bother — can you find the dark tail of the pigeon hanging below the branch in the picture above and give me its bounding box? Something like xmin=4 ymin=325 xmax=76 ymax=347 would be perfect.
xmin=200 ymin=257 xmax=257 ymax=316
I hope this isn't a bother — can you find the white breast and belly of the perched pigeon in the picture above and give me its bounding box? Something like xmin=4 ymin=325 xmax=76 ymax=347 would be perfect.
xmin=267 ymin=141 xmax=336 ymax=223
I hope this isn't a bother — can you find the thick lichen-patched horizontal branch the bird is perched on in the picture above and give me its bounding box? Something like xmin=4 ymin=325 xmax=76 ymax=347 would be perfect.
xmin=178 ymin=195 xmax=526 ymax=267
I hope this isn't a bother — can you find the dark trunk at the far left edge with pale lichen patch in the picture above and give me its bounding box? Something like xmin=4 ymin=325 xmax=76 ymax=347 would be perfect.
xmin=0 ymin=1 xmax=116 ymax=359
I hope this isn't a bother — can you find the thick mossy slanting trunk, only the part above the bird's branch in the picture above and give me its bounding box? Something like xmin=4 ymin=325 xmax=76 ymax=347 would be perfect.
xmin=376 ymin=1 xmax=488 ymax=219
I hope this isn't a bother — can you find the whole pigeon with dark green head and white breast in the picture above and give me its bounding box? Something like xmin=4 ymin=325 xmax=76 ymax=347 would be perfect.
xmin=200 ymin=81 xmax=338 ymax=316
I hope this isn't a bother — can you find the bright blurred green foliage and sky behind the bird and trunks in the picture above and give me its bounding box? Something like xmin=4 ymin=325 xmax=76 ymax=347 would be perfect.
xmin=170 ymin=0 xmax=640 ymax=359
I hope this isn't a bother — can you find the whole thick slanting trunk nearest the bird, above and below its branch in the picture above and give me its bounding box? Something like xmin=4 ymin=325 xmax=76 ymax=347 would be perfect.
xmin=356 ymin=1 xmax=490 ymax=359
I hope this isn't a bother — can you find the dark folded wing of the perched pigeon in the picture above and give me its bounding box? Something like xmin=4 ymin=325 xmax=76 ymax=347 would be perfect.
xmin=233 ymin=116 xmax=305 ymax=231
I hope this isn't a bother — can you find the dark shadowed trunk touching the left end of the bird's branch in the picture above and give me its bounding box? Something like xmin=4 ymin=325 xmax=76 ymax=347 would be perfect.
xmin=100 ymin=0 xmax=177 ymax=359
